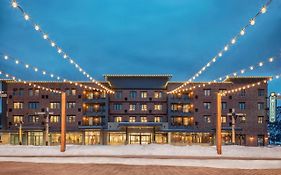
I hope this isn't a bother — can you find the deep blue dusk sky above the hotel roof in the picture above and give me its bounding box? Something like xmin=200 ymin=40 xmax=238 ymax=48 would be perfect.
xmin=0 ymin=0 xmax=281 ymax=92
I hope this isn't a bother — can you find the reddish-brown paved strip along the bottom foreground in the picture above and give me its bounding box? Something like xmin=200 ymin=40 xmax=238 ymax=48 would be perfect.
xmin=0 ymin=162 xmax=281 ymax=175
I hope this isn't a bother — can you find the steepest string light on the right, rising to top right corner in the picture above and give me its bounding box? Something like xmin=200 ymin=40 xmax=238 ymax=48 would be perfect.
xmin=174 ymin=0 xmax=272 ymax=93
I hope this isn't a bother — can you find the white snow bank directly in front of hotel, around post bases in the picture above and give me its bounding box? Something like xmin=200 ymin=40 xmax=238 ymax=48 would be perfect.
xmin=0 ymin=144 xmax=281 ymax=158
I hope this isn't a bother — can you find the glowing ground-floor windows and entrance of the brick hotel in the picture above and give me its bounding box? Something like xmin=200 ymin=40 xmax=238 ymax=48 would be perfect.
xmin=0 ymin=127 xmax=268 ymax=146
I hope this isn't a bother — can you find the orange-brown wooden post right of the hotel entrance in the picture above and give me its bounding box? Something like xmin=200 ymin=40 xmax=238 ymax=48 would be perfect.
xmin=216 ymin=93 xmax=222 ymax=154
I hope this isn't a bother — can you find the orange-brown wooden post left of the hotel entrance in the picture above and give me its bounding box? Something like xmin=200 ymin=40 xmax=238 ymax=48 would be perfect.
xmin=60 ymin=92 xmax=66 ymax=152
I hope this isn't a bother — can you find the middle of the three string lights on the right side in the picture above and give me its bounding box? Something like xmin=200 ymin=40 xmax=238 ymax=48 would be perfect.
xmin=167 ymin=57 xmax=280 ymax=94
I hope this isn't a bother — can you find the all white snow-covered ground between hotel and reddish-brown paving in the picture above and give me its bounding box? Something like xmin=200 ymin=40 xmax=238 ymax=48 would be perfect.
xmin=0 ymin=144 xmax=281 ymax=169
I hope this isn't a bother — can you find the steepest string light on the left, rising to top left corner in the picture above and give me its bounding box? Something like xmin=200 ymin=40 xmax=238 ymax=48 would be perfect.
xmin=9 ymin=0 xmax=114 ymax=93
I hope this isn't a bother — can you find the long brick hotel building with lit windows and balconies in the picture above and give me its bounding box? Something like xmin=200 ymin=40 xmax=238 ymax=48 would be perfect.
xmin=0 ymin=75 xmax=269 ymax=146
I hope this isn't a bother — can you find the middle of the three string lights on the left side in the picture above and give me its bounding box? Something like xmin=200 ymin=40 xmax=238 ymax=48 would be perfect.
xmin=0 ymin=53 xmax=112 ymax=93
